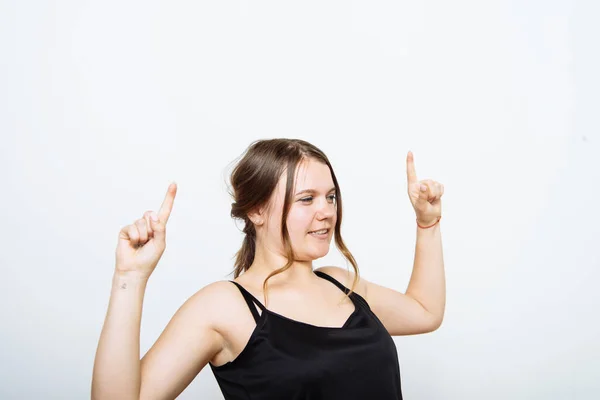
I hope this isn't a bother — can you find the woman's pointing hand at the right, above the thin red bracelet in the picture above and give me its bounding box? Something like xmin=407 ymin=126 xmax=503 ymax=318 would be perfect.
xmin=406 ymin=151 xmax=444 ymax=226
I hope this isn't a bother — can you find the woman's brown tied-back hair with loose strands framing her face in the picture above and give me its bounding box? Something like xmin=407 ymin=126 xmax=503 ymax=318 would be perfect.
xmin=230 ymin=138 xmax=359 ymax=304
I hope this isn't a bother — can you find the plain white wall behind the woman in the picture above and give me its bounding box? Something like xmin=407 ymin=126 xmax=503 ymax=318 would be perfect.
xmin=0 ymin=0 xmax=600 ymax=400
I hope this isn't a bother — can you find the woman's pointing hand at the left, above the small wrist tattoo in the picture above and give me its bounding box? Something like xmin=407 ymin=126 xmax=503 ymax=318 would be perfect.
xmin=116 ymin=183 xmax=177 ymax=279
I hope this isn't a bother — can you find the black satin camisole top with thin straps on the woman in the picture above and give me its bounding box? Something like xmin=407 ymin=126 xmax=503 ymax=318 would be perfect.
xmin=210 ymin=271 xmax=402 ymax=400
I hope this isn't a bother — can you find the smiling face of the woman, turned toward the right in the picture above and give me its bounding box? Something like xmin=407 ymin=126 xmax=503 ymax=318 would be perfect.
xmin=266 ymin=159 xmax=337 ymax=261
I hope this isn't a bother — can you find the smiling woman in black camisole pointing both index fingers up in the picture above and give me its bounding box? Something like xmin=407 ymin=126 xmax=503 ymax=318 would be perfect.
xmin=92 ymin=139 xmax=445 ymax=400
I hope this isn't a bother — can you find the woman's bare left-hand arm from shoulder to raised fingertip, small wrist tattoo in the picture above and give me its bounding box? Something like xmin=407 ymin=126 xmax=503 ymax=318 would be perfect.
xmin=92 ymin=184 xmax=230 ymax=400
